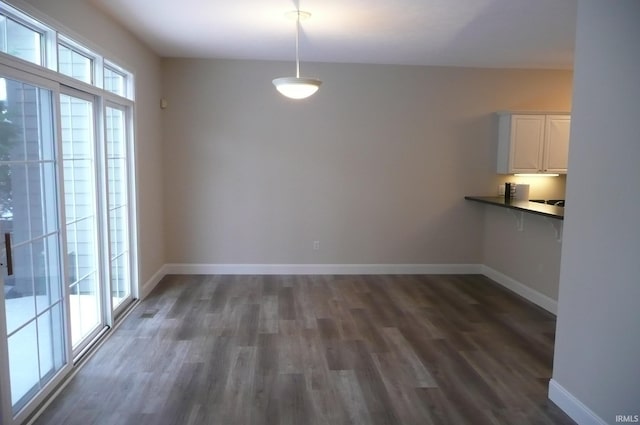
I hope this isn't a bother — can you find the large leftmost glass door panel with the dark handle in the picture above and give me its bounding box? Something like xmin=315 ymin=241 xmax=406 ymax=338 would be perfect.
xmin=0 ymin=78 xmax=67 ymax=413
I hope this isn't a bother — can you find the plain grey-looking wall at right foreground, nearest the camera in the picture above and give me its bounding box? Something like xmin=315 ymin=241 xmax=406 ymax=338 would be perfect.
xmin=550 ymin=0 xmax=640 ymax=424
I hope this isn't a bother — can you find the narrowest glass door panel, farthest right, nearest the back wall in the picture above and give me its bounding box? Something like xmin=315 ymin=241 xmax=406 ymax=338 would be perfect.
xmin=105 ymin=106 xmax=131 ymax=310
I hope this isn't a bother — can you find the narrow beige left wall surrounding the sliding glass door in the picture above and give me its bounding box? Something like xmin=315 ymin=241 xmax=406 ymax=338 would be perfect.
xmin=16 ymin=0 xmax=165 ymax=285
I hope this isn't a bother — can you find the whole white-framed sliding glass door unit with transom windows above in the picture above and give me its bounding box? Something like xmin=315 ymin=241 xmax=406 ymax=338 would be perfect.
xmin=0 ymin=0 xmax=137 ymax=425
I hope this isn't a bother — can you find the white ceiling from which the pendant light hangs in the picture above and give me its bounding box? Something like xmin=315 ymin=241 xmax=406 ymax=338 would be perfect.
xmin=91 ymin=0 xmax=577 ymax=69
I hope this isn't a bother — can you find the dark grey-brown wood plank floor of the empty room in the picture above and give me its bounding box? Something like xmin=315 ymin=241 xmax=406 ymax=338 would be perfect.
xmin=36 ymin=275 xmax=573 ymax=425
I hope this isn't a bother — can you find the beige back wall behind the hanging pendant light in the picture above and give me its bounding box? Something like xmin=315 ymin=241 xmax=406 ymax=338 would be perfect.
xmin=163 ymin=59 xmax=572 ymax=264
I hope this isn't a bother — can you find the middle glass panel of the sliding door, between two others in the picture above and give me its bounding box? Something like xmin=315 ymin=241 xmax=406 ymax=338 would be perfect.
xmin=60 ymin=94 xmax=104 ymax=351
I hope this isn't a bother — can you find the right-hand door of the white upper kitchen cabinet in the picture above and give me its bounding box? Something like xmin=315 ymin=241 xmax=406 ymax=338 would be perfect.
xmin=542 ymin=115 xmax=571 ymax=173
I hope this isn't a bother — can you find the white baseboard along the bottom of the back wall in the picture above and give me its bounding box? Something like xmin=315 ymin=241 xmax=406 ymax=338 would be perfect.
xmin=161 ymin=264 xmax=481 ymax=274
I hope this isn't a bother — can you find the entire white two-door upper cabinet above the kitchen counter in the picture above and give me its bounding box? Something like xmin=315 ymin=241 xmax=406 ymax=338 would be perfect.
xmin=498 ymin=112 xmax=571 ymax=174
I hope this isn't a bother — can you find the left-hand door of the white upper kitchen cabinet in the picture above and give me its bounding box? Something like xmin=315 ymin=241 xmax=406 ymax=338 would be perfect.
xmin=509 ymin=115 xmax=545 ymax=173
